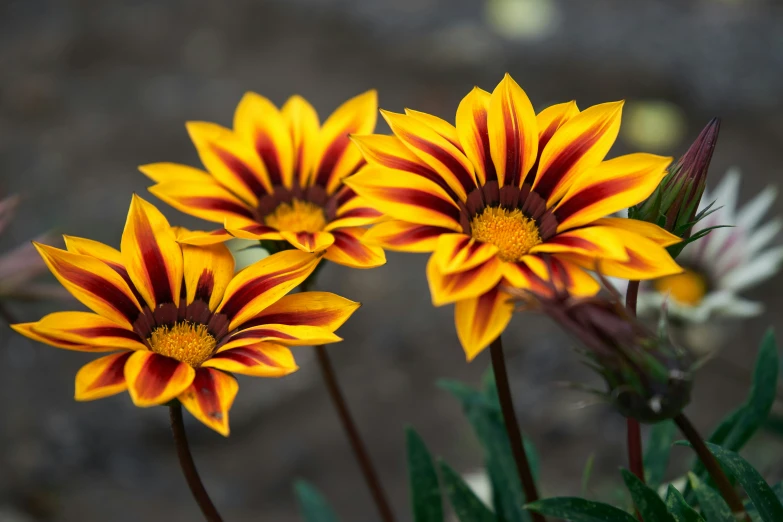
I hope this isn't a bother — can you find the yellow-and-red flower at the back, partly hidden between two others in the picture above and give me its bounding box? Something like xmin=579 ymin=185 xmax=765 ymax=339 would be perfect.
xmin=140 ymin=91 xmax=386 ymax=268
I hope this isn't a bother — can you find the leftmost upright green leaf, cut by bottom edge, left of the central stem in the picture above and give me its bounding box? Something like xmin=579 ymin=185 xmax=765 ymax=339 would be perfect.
xmin=405 ymin=428 xmax=443 ymax=522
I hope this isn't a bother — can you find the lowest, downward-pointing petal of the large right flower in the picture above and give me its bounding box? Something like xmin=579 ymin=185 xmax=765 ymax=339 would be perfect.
xmin=454 ymin=286 xmax=514 ymax=362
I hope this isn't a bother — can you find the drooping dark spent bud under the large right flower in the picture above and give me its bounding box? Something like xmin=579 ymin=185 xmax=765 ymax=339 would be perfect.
xmin=515 ymin=291 xmax=692 ymax=423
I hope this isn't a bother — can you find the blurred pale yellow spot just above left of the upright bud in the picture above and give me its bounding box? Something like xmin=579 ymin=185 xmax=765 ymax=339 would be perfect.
xmin=621 ymin=100 xmax=685 ymax=150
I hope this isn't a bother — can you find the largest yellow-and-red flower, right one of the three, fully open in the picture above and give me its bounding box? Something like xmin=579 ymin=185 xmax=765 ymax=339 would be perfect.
xmin=346 ymin=75 xmax=680 ymax=359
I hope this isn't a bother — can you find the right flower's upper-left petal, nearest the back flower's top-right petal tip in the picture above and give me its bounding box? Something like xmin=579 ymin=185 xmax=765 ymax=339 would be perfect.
xmin=381 ymin=110 xmax=476 ymax=201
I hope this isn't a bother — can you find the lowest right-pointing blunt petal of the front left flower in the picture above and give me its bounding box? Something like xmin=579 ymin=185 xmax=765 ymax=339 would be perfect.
xmin=201 ymin=343 xmax=299 ymax=377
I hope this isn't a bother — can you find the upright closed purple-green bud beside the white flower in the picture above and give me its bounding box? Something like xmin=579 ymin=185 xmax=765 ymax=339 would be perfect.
xmin=628 ymin=118 xmax=720 ymax=257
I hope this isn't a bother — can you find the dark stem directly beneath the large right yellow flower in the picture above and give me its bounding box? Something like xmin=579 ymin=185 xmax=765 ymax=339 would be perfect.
xmin=489 ymin=336 xmax=546 ymax=522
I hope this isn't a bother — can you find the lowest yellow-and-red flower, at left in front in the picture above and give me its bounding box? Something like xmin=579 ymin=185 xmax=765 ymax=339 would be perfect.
xmin=14 ymin=196 xmax=359 ymax=435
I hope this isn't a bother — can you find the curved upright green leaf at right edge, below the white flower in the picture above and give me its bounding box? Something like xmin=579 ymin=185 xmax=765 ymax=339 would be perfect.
xmin=685 ymin=329 xmax=779 ymax=502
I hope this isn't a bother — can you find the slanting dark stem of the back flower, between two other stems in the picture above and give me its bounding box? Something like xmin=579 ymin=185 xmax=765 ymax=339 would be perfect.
xmin=315 ymin=346 xmax=394 ymax=522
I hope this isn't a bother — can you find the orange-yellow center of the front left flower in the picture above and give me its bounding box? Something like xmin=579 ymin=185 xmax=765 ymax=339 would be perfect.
xmin=147 ymin=321 xmax=217 ymax=368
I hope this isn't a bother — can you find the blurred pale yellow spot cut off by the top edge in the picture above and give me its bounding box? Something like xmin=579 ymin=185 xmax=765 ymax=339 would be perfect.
xmin=485 ymin=0 xmax=560 ymax=40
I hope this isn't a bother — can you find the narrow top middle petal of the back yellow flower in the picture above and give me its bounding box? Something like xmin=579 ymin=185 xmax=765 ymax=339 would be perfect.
xmin=281 ymin=95 xmax=320 ymax=187
